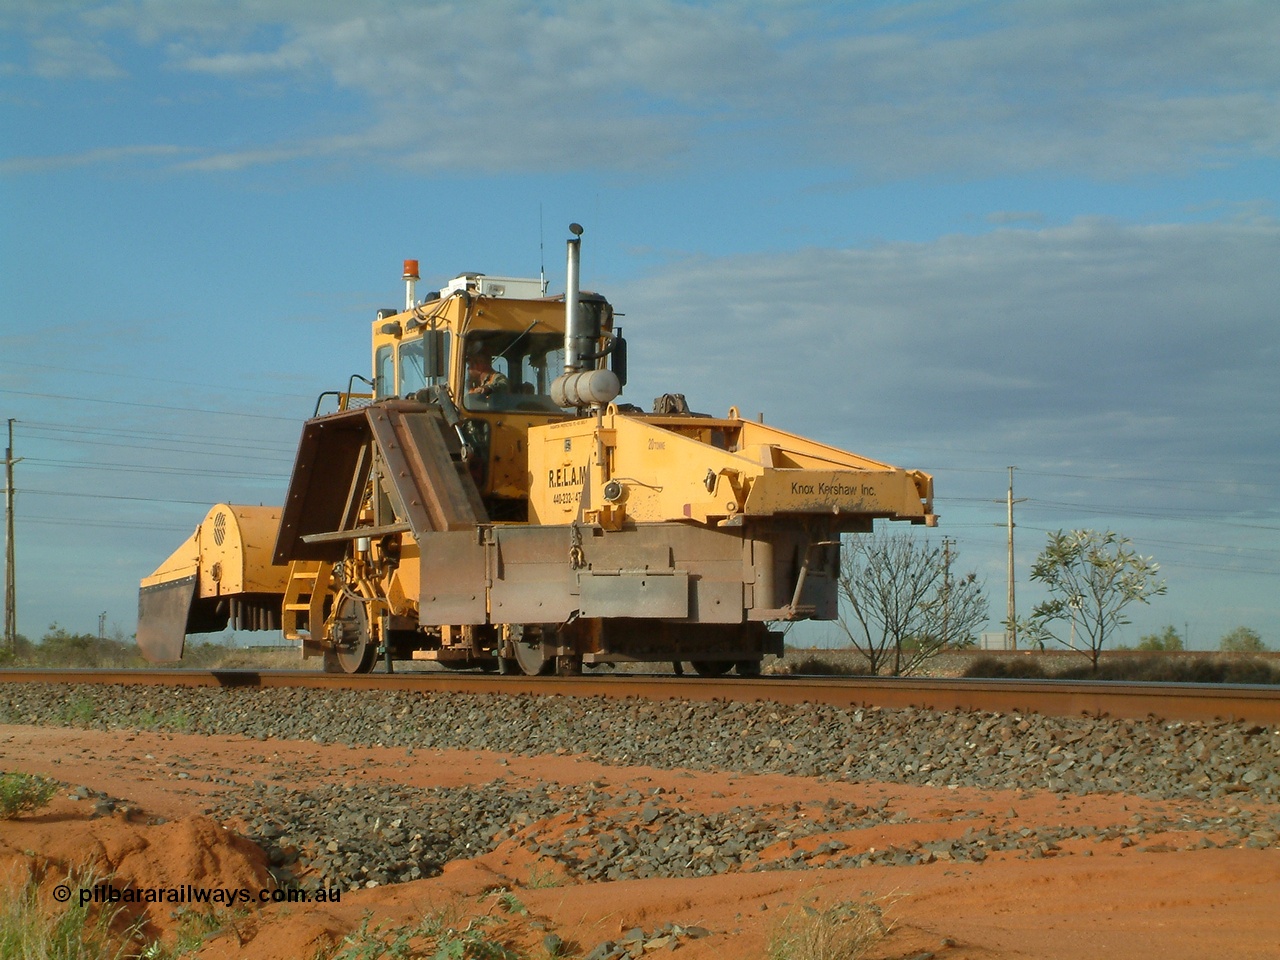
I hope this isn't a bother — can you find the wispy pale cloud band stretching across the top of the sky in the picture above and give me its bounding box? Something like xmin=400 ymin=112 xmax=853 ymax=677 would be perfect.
xmin=5 ymin=0 xmax=1280 ymax=178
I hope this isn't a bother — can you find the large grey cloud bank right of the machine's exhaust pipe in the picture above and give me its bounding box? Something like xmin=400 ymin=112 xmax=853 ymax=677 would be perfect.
xmin=616 ymin=220 xmax=1280 ymax=476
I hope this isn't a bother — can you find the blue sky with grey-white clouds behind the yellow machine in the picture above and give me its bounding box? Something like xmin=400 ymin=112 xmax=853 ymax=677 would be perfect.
xmin=0 ymin=0 xmax=1280 ymax=648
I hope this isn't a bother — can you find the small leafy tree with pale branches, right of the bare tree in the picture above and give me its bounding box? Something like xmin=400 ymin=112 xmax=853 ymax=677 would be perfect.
xmin=1024 ymin=530 xmax=1166 ymax=669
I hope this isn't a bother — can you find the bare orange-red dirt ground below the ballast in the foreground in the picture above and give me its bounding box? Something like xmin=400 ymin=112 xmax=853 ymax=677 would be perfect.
xmin=0 ymin=726 xmax=1280 ymax=960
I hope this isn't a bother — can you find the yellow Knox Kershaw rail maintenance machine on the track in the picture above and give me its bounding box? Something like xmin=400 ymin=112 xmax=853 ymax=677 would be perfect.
xmin=137 ymin=224 xmax=937 ymax=675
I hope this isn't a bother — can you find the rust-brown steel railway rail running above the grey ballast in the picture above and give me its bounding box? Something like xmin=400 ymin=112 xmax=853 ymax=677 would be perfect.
xmin=0 ymin=669 xmax=1280 ymax=726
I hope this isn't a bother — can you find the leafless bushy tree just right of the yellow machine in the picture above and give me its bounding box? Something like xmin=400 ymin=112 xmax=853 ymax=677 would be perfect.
xmin=837 ymin=532 xmax=987 ymax=677
